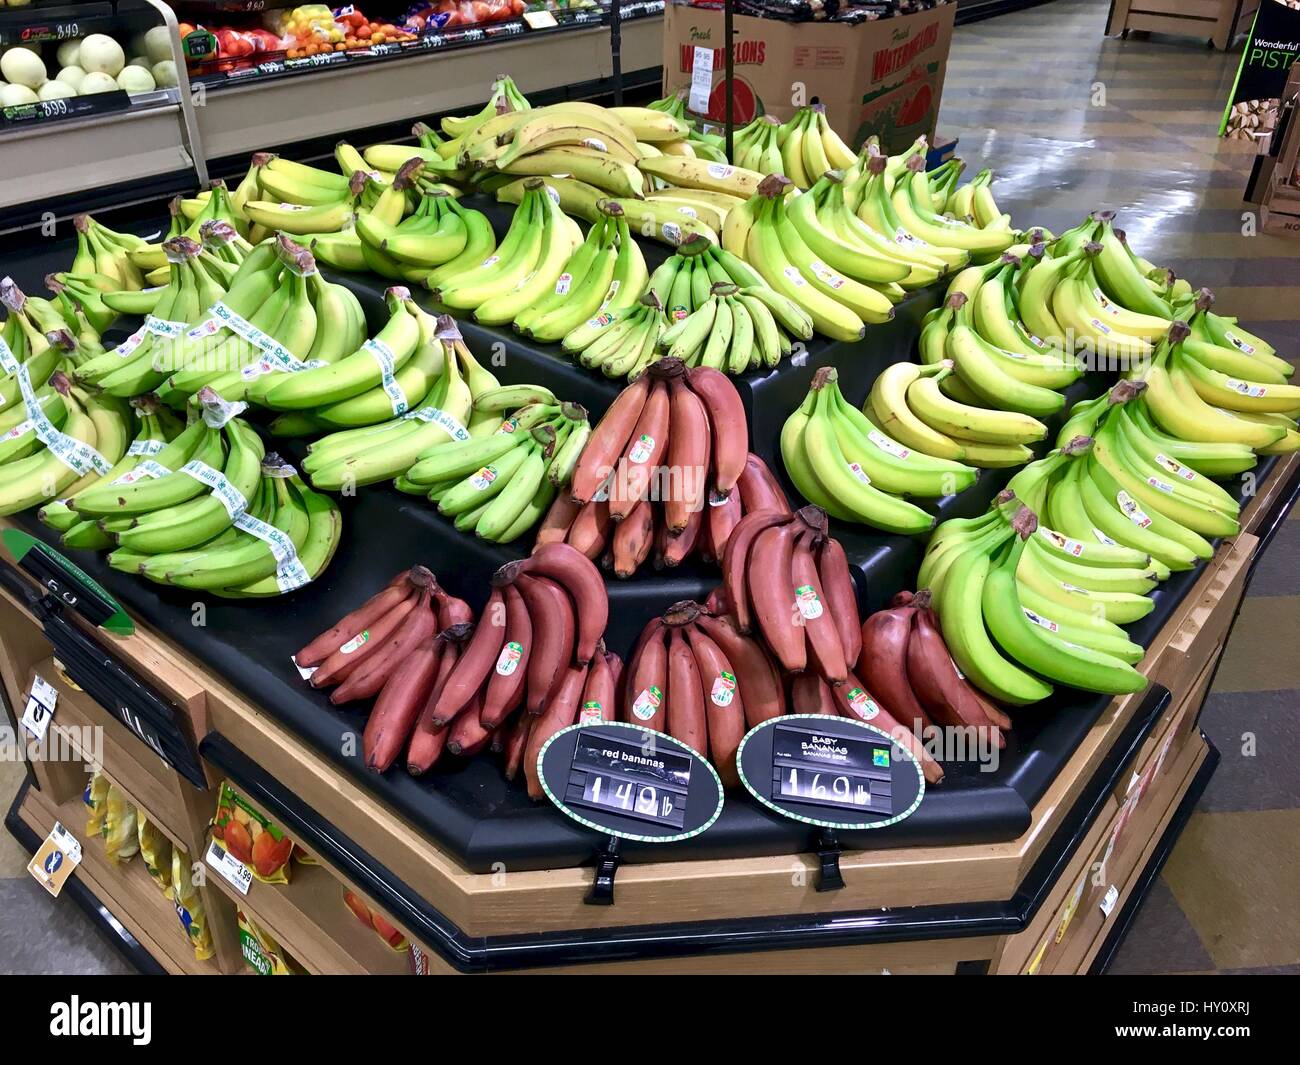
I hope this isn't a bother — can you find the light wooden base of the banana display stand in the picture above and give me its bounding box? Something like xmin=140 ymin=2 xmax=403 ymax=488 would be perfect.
xmin=0 ymin=456 xmax=1300 ymax=974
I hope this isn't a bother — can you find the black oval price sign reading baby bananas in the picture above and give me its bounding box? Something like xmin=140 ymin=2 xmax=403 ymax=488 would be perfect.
xmin=736 ymin=714 xmax=926 ymax=830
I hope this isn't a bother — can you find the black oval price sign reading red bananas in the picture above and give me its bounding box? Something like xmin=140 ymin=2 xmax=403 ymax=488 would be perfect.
xmin=537 ymin=722 xmax=723 ymax=843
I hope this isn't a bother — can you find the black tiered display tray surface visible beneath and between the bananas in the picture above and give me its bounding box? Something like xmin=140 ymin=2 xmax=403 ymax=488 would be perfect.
xmin=5 ymin=197 xmax=1294 ymax=873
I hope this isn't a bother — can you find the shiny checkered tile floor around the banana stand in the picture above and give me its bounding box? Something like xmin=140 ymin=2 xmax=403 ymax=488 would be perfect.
xmin=0 ymin=0 xmax=1300 ymax=973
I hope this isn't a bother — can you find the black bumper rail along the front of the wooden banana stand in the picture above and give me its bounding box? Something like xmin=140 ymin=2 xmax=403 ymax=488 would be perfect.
xmin=199 ymin=685 xmax=1170 ymax=973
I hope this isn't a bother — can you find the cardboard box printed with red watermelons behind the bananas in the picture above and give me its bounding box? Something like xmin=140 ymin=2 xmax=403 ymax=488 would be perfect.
xmin=663 ymin=4 xmax=957 ymax=152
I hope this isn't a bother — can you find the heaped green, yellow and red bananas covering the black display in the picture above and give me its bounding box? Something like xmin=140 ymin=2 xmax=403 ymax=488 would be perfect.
xmin=0 ymin=70 xmax=1300 ymax=847
